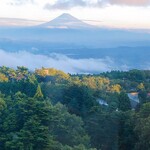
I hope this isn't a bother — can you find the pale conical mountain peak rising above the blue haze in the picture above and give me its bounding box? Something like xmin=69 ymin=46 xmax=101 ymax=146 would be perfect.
xmin=38 ymin=13 xmax=96 ymax=29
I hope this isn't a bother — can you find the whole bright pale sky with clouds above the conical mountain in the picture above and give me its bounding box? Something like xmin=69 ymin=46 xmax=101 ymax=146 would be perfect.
xmin=0 ymin=0 xmax=150 ymax=29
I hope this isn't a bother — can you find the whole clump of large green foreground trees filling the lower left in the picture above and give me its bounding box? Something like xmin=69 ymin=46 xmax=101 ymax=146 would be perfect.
xmin=0 ymin=92 xmax=89 ymax=150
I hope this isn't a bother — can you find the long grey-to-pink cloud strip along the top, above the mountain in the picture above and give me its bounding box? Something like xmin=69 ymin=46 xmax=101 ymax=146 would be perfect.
xmin=45 ymin=0 xmax=150 ymax=9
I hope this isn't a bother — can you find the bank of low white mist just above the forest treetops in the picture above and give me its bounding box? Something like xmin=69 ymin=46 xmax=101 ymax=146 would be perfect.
xmin=0 ymin=50 xmax=129 ymax=73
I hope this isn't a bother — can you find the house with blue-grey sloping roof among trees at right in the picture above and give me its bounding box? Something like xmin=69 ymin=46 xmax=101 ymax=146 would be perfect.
xmin=128 ymin=92 xmax=140 ymax=108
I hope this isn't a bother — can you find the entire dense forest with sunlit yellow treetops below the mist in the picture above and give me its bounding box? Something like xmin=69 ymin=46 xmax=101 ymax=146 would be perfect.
xmin=0 ymin=66 xmax=150 ymax=150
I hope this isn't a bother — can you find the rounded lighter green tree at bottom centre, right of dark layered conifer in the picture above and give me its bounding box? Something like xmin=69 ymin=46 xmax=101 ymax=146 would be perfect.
xmin=50 ymin=104 xmax=89 ymax=147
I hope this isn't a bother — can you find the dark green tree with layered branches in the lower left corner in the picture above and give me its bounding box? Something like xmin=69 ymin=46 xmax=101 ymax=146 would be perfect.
xmin=0 ymin=93 xmax=51 ymax=150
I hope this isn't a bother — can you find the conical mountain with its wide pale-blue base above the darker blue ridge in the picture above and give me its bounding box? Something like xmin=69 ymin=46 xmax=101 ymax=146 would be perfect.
xmin=0 ymin=13 xmax=150 ymax=51
